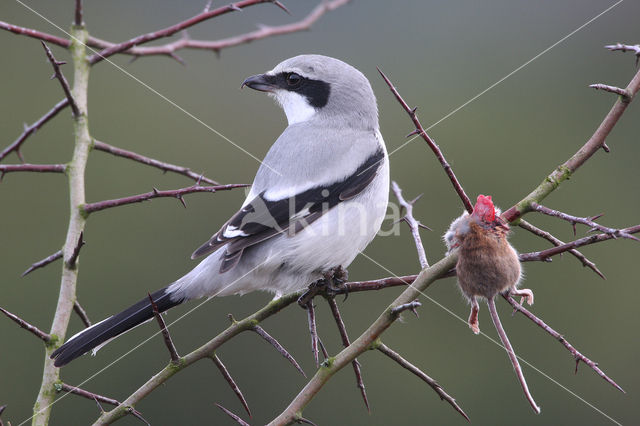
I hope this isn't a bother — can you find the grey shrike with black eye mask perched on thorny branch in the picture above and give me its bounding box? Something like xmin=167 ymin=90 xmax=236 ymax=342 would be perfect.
xmin=51 ymin=55 xmax=389 ymax=367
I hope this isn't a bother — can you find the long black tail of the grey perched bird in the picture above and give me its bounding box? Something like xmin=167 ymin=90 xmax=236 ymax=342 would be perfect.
xmin=51 ymin=288 xmax=182 ymax=367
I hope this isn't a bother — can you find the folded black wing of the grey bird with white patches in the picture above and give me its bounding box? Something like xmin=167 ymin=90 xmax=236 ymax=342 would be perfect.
xmin=191 ymin=150 xmax=384 ymax=273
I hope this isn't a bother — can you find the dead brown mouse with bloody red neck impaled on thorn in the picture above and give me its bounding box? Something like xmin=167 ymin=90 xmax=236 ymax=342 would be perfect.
xmin=444 ymin=195 xmax=540 ymax=413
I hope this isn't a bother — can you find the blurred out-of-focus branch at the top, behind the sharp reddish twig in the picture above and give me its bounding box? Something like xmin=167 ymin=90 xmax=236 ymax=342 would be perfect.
xmin=87 ymin=0 xmax=351 ymax=62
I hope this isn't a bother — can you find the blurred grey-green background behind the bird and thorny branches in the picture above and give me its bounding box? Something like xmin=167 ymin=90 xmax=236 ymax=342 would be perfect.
xmin=0 ymin=0 xmax=640 ymax=425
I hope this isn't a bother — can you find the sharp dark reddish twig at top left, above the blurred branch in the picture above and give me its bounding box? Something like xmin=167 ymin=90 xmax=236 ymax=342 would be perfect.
xmin=89 ymin=0 xmax=280 ymax=65
